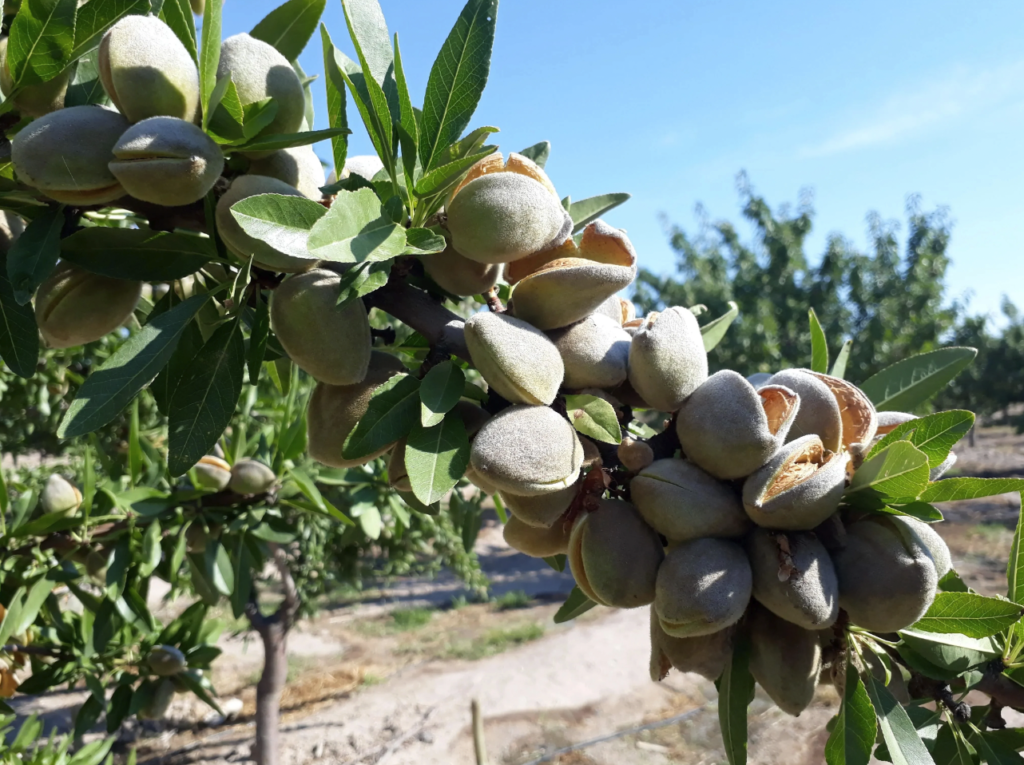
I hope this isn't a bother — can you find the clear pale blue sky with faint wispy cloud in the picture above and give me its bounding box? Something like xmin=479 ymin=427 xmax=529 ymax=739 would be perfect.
xmin=224 ymin=0 xmax=1024 ymax=323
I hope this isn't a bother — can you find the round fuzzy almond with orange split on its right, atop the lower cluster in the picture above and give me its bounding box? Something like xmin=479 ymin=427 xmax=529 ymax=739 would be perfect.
xmin=676 ymin=370 xmax=800 ymax=479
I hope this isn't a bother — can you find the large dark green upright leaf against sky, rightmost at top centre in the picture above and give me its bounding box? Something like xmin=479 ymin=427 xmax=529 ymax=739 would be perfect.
xmin=420 ymin=0 xmax=498 ymax=172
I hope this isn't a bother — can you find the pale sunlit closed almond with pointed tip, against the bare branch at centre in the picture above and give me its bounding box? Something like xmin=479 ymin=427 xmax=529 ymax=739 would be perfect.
xmin=465 ymin=311 xmax=565 ymax=406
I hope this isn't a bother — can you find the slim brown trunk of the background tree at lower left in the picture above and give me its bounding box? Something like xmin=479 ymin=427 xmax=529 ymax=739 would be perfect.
xmin=246 ymin=544 xmax=299 ymax=765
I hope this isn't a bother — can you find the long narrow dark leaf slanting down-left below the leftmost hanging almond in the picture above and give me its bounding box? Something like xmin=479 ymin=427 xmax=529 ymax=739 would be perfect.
xmin=57 ymin=293 xmax=210 ymax=438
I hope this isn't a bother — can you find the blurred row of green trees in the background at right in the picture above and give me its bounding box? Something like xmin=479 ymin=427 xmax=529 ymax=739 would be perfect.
xmin=634 ymin=174 xmax=1024 ymax=424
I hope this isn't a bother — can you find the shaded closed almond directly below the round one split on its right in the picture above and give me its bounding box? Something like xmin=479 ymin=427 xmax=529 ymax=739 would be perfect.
xmin=630 ymin=458 xmax=751 ymax=542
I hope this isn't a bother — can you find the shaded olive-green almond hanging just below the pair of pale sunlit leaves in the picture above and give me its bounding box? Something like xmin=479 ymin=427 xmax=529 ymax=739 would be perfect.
xmin=270 ymin=268 xmax=373 ymax=385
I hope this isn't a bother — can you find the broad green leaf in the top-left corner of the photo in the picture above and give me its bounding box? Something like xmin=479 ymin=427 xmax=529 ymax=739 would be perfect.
xmin=5 ymin=0 xmax=78 ymax=92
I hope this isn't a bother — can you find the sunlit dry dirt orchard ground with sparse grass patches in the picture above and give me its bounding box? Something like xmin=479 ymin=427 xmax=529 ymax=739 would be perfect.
xmin=8 ymin=429 xmax=1024 ymax=765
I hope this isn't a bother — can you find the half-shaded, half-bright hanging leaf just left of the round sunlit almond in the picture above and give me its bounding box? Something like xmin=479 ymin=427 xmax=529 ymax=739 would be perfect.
xmin=406 ymin=415 xmax=469 ymax=505
